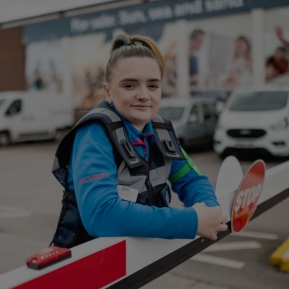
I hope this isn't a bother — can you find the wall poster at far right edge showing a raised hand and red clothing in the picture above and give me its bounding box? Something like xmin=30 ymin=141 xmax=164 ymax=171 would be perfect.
xmin=264 ymin=7 xmax=289 ymax=84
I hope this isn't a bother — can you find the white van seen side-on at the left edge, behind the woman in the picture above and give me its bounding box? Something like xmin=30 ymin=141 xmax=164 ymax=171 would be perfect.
xmin=0 ymin=91 xmax=74 ymax=146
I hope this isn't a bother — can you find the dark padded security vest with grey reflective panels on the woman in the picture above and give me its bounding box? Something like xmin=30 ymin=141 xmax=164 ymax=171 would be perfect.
xmin=52 ymin=101 xmax=185 ymax=248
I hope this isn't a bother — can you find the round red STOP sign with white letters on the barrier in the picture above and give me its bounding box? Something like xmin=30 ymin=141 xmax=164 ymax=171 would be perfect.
xmin=231 ymin=160 xmax=266 ymax=233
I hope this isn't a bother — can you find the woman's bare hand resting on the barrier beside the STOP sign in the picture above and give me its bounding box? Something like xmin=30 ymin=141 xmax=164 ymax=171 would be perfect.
xmin=193 ymin=203 xmax=228 ymax=241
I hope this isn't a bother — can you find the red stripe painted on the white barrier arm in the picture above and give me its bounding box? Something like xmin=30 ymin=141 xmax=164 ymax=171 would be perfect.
xmin=12 ymin=240 xmax=126 ymax=289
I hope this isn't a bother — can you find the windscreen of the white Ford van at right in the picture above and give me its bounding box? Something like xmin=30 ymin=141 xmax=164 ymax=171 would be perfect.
xmin=229 ymin=91 xmax=288 ymax=111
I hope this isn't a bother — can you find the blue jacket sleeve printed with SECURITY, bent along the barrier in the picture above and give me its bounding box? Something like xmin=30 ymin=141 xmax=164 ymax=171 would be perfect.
xmin=69 ymin=123 xmax=198 ymax=239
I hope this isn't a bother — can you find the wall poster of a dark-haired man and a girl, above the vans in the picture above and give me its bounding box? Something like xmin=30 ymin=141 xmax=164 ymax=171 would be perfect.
xmin=188 ymin=15 xmax=252 ymax=99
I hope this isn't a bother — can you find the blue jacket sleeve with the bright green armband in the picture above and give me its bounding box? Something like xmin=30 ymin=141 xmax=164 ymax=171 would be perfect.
xmin=170 ymin=153 xmax=219 ymax=207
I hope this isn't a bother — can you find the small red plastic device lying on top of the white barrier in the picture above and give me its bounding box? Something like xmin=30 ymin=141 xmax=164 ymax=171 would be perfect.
xmin=26 ymin=246 xmax=71 ymax=270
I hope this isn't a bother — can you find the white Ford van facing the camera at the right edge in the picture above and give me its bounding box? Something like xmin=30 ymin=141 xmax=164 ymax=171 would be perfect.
xmin=214 ymin=85 xmax=289 ymax=157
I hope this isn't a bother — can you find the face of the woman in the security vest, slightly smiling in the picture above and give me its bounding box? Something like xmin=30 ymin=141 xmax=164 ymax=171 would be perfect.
xmin=104 ymin=57 xmax=161 ymax=131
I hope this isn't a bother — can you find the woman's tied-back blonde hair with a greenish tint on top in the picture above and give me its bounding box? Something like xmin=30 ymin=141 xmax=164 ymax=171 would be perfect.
xmin=104 ymin=34 xmax=165 ymax=82
